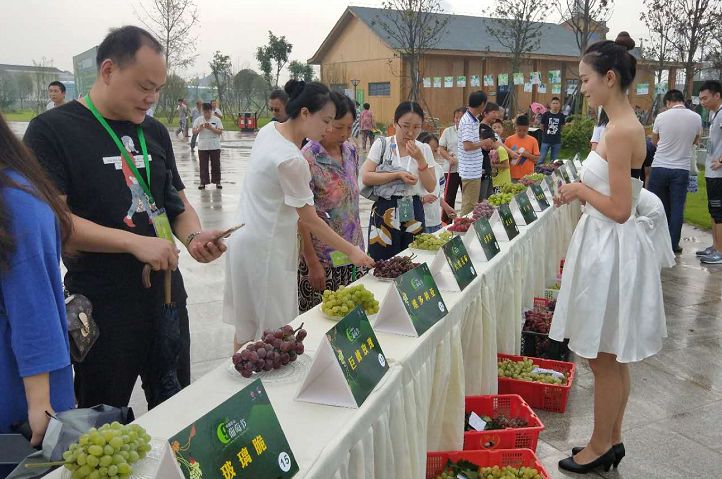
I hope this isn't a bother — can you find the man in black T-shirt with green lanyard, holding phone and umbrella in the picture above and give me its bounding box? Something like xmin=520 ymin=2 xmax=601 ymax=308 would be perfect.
xmin=24 ymin=27 xmax=225 ymax=407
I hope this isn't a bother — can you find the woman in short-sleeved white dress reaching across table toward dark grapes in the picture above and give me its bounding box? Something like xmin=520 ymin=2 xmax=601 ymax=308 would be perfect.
xmin=223 ymin=80 xmax=373 ymax=351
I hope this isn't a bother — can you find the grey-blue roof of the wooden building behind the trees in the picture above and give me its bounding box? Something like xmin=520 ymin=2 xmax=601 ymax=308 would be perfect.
xmin=309 ymin=6 xmax=603 ymax=64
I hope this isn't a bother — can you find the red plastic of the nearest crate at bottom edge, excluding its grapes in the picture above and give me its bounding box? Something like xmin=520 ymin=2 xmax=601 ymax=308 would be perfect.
xmin=426 ymin=449 xmax=550 ymax=479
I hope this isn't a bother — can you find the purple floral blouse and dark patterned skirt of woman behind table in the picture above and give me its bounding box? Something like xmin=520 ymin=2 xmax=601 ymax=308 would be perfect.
xmin=298 ymin=141 xmax=364 ymax=312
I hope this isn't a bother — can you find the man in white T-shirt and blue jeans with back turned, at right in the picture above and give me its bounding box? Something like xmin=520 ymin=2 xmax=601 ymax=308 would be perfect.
xmin=647 ymin=90 xmax=702 ymax=254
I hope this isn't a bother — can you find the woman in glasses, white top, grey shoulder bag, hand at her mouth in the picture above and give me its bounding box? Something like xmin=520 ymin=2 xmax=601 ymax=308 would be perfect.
xmin=361 ymin=101 xmax=436 ymax=261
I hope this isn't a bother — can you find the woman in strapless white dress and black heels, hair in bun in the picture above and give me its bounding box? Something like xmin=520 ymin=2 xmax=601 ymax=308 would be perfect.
xmin=549 ymin=32 xmax=667 ymax=473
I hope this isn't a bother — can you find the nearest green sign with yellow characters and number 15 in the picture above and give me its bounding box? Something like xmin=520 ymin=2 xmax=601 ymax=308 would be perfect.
xmin=169 ymin=379 xmax=298 ymax=479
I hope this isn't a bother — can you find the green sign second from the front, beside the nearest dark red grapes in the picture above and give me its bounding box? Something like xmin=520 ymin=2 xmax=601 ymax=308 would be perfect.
xmin=326 ymin=306 xmax=389 ymax=406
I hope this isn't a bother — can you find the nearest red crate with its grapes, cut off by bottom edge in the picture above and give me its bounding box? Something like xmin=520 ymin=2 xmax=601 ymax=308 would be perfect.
xmin=426 ymin=449 xmax=551 ymax=479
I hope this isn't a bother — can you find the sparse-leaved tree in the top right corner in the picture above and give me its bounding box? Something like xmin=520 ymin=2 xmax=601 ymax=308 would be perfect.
xmin=663 ymin=0 xmax=722 ymax=97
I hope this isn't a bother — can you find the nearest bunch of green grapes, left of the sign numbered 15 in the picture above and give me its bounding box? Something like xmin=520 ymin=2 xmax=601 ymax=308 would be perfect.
xmin=63 ymin=422 xmax=150 ymax=479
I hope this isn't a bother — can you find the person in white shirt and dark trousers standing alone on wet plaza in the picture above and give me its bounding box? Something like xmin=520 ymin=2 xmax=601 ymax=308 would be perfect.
xmin=193 ymin=103 xmax=223 ymax=190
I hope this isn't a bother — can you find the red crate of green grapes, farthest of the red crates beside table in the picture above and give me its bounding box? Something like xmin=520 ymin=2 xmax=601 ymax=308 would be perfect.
xmin=497 ymin=353 xmax=576 ymax=412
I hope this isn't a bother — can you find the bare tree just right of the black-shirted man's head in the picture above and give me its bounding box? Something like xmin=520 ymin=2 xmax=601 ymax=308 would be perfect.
xmin=134 ymin=0 xmax=198 ymax=71
